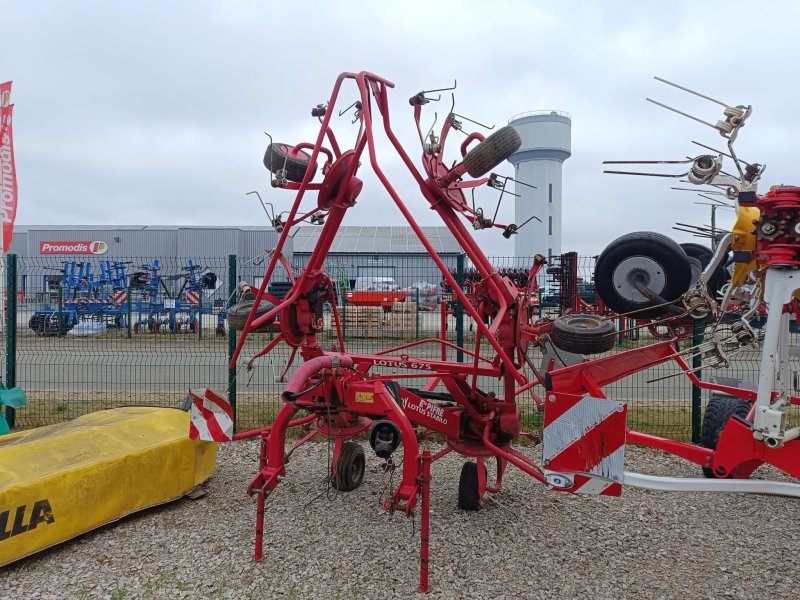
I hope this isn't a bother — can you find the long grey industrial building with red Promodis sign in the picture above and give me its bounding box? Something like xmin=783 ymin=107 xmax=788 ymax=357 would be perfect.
xmin=4 ymin=225 xmax=462 ymax=295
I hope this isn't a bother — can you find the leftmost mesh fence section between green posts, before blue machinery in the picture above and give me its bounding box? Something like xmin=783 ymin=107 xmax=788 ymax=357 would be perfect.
xmin=9 ymin=256 xmax=227 ymax=427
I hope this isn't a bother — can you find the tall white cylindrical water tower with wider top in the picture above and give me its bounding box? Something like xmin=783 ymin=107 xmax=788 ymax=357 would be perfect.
xmin=508 ymin=110 xmax=572 ymax=266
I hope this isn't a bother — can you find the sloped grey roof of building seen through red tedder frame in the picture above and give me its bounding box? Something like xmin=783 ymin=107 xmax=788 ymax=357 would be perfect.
xmin=293 ymin=225 xmax=462 ymax=254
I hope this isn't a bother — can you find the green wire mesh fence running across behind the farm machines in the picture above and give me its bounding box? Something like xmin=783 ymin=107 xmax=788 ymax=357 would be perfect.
xmin=6 ymin=255 xmax=800 ymax=439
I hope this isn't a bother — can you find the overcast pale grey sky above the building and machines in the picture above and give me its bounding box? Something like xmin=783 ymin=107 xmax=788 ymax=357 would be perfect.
xmin=0 ymin=0 xmax=800 ymax=255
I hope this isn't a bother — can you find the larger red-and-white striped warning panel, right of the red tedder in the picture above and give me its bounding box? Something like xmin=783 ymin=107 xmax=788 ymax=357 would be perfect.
xmin=542 ymin=392 xmax=628 ymax=496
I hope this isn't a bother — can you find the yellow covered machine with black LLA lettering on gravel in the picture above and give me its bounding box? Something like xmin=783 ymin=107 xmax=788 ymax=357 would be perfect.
xmin=0 ymin=407 xmax=217 ymax=566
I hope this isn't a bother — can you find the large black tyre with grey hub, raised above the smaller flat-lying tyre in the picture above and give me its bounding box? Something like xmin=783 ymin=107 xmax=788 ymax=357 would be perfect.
xmin=594 ymin=231 xmax=692 ymax=319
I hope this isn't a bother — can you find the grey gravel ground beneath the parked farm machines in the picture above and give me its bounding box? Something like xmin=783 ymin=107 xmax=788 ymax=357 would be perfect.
xmin=0 ymin=441 xmax=800 ymax=600
